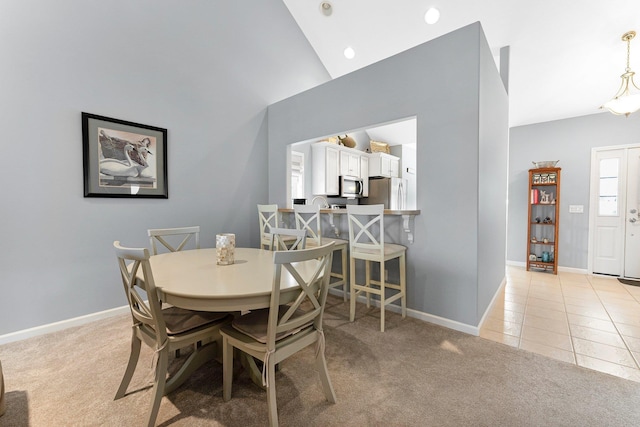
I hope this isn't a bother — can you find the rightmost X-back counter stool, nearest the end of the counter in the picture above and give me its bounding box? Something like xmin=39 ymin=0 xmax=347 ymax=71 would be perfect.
xmin=347 ymin=205 xmax=407 ymax=332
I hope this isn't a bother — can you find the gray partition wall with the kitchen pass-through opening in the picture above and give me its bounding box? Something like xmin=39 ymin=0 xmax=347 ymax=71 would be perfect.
xmin=269 ymin=23 xmax=507 ymax=325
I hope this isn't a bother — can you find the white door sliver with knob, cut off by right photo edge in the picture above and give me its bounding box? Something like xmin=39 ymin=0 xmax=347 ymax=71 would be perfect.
xmin=623 ymin=148 xmax=640 ymax=279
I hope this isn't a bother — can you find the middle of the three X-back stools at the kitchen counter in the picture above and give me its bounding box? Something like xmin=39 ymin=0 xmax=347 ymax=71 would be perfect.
xmin=293 ymin=205 xmax=349 ymax=301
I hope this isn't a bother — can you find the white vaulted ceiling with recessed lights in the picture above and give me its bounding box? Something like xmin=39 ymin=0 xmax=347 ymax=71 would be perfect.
xmin=283 ymin=0 xmax=640 ymax=126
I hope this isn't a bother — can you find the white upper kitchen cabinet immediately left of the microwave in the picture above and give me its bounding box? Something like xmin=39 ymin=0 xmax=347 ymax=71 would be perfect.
xmin=311 ymin=142 xmax=340 ymax=196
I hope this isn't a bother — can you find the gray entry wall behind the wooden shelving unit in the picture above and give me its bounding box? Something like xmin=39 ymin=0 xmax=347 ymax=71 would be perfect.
xmin=507 ymin=112 xmax=640 ymax=269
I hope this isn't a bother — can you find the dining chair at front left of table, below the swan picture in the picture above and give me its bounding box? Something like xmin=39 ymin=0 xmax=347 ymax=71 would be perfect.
xmin=113 ymin=241 xmax=232 ymax=426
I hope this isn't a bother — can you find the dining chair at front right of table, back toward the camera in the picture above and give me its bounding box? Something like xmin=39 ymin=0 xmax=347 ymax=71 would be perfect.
xmin=220 ymin=243 xmax=336 ymax=426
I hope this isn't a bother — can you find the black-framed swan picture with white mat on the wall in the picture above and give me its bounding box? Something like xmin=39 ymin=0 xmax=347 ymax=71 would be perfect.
xmin=82 ymin=113 xmax=169 ymax=199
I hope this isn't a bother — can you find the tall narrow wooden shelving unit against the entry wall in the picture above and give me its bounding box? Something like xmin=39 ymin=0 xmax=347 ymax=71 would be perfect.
xmin=527 ymin=168 xmax=561 ymax=274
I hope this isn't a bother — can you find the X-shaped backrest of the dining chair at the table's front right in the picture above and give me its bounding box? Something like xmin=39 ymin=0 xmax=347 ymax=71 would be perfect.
xmin=267 ymin=242 xmax=333 ymax=349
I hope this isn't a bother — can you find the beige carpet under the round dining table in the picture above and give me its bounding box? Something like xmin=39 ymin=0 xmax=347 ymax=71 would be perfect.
xmin=0 ymin=296 xmax=640 ymax=427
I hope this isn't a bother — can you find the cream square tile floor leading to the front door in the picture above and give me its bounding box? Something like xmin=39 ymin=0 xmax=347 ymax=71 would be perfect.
xmin=480 ymin=266 xmax=640 ymax=382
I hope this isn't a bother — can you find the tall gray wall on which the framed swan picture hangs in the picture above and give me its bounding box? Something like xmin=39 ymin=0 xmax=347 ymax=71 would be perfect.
xmin=0 ymin=0 xmax=329 ymax=335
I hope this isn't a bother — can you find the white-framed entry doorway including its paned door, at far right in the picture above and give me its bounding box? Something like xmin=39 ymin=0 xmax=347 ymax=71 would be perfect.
xmin=589 ymin=145 xmax=640 ymax=279
